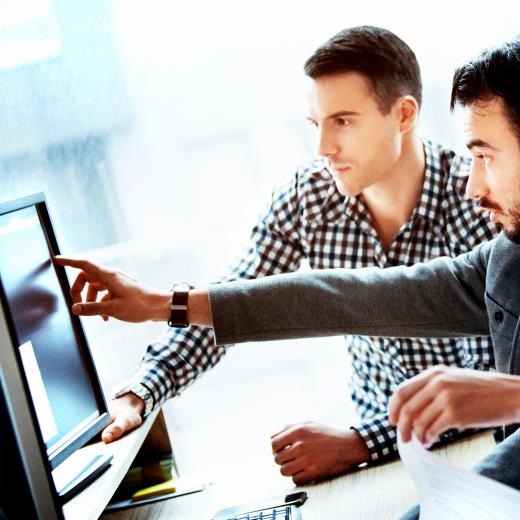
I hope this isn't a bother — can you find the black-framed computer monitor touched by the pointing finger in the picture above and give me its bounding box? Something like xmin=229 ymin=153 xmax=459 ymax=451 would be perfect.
xmin=0 ymin=193 xmax=109 ymax=500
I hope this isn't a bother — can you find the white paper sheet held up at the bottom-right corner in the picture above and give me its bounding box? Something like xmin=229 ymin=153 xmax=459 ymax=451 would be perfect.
xmin=397 ymin=432 xmax=520 ymax=520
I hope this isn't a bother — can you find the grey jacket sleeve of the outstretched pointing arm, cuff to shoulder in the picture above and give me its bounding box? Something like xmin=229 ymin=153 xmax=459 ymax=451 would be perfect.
xmin=205 ymin=248 xmax=489 ymax=344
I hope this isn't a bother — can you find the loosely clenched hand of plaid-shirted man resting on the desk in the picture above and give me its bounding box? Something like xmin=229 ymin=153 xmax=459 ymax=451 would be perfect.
xmin=271 ymin=422 xmax=369 ymax=484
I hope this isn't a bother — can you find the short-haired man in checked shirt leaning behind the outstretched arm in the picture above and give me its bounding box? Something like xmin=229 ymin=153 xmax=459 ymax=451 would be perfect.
xmin=92 ymin=27 xmax=495 ymax=483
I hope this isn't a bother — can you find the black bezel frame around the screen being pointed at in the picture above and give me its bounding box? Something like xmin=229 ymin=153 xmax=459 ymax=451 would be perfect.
xmin=0 ymin=193 xmax=110 ymax=468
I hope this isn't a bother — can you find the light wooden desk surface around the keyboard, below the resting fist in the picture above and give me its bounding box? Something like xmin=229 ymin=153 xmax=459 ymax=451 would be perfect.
xmin=102 ymin=432 xmax=495 ymax=520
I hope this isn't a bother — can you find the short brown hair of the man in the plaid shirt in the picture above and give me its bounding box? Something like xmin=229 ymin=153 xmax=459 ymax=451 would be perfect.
xmin=304 ymin=25 xmax=422 ymax=113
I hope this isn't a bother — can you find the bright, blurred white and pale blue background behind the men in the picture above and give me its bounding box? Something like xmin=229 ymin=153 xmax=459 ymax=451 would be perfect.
xmin=0 ymin=0 xmax=520 ymax=472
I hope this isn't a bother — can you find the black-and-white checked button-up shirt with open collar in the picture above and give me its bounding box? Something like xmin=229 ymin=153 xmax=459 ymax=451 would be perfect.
xmin=133 ymin=140 xmax=496 ymax=461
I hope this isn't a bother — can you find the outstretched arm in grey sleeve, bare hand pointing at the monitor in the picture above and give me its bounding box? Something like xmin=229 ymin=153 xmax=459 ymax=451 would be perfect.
xmin=56 ymin=242 xmax=493 ymax=344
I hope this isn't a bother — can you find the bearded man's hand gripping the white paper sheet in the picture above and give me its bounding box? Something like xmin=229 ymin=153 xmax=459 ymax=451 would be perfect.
xmin=388 ymin=366 xmax=520 ymax=445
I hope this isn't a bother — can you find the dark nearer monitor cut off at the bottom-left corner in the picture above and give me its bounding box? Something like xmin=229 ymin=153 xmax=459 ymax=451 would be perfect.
xmin=0 ymin=344 xmax=63 ymax=520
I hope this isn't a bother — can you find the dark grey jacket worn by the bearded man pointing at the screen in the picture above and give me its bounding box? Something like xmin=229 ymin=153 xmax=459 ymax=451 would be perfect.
xmin=209 ymin=234 xmax=520 ymax=374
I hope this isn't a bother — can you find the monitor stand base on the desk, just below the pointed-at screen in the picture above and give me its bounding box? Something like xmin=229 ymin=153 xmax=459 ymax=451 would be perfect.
xmin=52 ymin=450 xmax=114 ymax=502
